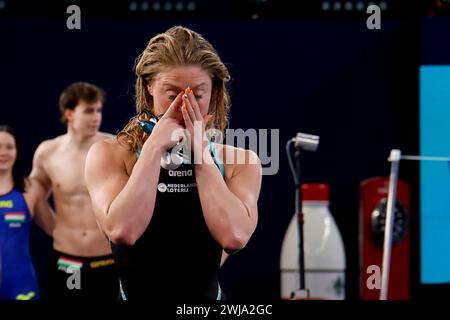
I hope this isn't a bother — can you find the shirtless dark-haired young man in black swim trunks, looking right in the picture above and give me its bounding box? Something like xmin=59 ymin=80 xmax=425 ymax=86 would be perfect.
xmin=30 ymin=82 xmax=119 ymax=300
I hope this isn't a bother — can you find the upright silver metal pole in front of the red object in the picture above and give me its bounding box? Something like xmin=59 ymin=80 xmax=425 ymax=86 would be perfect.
xmin=380 ymin=149 xmax=401 ymax=300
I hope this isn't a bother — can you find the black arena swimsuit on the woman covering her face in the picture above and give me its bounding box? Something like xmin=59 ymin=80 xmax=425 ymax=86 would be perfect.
xmin=111 ymin=146 xmax=223 ymax=301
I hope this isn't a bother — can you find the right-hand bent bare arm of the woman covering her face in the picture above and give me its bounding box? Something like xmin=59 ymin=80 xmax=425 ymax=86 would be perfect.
xmin=195 ymin=150 xmax=262 ymax=255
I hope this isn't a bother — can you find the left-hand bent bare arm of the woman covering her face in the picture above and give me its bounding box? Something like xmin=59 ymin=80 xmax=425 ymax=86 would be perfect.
xmin=85 ymin=141 xmax=161 ymax=245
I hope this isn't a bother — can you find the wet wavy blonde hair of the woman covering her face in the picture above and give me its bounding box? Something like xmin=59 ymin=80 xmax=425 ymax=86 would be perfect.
xmin=117 ymin=26 xmax=230 ymax=152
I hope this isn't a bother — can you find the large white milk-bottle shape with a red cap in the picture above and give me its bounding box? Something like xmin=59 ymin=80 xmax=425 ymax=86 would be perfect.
xmin=280 ymin=183 xmax=346 ymax=300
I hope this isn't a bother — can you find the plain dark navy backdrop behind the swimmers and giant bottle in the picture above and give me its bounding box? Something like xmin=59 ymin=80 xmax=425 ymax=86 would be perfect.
xmin=0 ymin=0 xmax=450 ymax=299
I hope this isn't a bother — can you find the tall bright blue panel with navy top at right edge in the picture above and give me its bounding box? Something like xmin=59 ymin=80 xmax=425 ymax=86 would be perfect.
xmin=420 ymin=18 xmax=450 ymax=288
